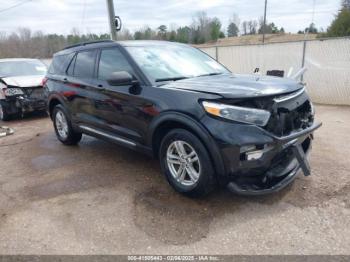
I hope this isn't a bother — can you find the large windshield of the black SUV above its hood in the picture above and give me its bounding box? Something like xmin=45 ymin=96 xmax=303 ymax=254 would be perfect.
xmin=126 ymin=45 xmax=230 ymax=82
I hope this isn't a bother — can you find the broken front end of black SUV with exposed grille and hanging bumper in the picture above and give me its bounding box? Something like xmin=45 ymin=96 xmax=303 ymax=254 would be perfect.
xmin=229 ymin=88 xmax=321 ymax=195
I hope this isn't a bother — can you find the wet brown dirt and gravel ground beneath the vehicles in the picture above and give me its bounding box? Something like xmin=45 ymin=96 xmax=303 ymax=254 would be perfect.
xmin=0 ymin=106 xmax=350 ymax=254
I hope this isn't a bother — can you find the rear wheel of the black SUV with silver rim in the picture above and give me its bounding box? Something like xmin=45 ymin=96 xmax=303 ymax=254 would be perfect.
xmin=52 ymin=105 xmax=82 ymax=145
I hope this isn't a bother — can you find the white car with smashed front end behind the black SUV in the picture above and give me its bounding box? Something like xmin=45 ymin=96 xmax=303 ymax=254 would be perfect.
xmin=0 ymin=58 xmax=47 ymax=121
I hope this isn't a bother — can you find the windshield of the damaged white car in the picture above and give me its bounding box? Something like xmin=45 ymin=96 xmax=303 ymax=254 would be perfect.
xmin=0 ymin=60 xmax=46 ymax=77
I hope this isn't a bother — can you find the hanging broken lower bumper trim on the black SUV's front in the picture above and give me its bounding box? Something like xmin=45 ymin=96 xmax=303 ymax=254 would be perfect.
xmin=228 ymin=124 xmax=321 ymax=196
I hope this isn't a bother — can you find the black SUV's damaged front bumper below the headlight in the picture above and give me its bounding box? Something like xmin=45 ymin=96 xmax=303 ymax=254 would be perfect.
xmin=202 ymin=116 xmax=321 ymax=195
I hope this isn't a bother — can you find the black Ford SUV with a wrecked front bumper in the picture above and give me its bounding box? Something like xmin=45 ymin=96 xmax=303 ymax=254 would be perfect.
xmin=45 ymin=41 xmax=320 ymax=196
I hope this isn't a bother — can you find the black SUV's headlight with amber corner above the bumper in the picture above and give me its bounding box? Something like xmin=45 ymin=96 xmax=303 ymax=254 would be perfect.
xmin=202 ymin=101 xmax=271 ymax=126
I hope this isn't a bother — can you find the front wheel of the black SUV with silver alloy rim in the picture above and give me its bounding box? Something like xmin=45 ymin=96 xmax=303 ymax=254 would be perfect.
xmin=159 ymin=129 xmax=216 ymax=197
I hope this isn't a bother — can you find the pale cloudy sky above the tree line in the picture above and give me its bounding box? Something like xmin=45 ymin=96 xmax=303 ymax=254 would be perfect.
xmin=0 ymin=0 xmax=340 ymax=34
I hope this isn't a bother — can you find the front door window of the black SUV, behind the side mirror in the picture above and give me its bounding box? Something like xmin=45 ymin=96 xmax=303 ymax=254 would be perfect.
xmin=98 ymin=48 xmax=134 ymax=80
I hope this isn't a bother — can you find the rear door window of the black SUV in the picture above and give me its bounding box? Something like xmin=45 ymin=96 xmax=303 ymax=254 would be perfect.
xmin=74 ymin=50 xmax=96 ymax=78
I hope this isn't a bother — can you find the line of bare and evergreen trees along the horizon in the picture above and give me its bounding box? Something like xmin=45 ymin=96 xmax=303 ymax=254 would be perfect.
xmin=0 ymin=0 xmax=350 ymax=58
